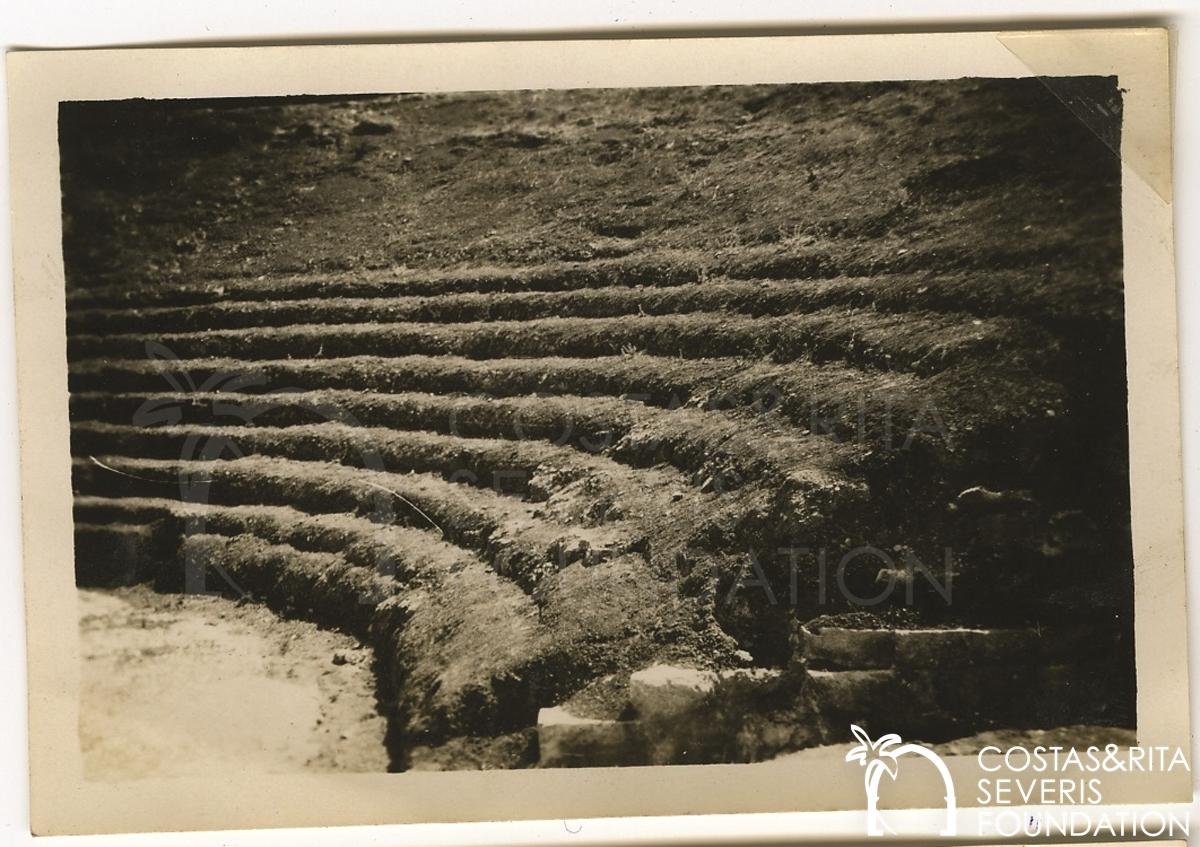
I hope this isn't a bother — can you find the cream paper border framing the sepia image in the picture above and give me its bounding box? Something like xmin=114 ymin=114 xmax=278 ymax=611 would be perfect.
xmin=7 ymin=29 xmax=1190 ymax=835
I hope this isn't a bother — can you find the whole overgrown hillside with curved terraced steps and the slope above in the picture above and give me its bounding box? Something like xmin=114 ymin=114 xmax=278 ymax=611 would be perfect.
xmin=60 ymin=79 xmax=1133 ymax=768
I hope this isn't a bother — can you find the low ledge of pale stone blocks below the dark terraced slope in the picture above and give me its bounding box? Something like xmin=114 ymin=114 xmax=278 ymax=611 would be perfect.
xmin=538 ymin=626 xmax=1113 ymax=767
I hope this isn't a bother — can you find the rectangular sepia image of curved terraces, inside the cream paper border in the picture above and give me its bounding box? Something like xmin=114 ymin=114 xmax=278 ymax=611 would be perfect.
xmin=7 ymin=36 xmax=1187 ymax=834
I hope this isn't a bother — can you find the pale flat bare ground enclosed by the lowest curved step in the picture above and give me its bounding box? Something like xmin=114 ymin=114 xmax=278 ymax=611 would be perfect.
xmin=79 ymin=585 xmax=388 ymax=781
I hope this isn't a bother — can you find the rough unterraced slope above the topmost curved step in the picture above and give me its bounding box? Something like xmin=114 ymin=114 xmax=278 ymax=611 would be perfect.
xmin=60 ymin=79 xmax=1120 ymax=289
